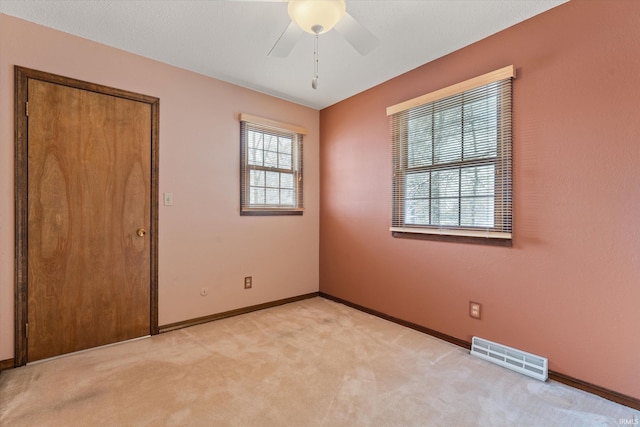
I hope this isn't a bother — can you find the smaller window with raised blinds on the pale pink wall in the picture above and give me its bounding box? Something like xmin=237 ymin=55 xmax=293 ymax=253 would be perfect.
xmin=240 ymin=114 xmax=306 ymax=215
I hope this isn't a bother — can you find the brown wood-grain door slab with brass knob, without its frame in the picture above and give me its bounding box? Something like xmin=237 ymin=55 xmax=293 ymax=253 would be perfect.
xmin=15 ymin=67 xmax=157 ymax=362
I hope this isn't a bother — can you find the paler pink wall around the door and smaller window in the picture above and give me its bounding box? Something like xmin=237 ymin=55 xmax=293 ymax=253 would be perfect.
xmin=0 ymin=14 xmax=319 ymax=360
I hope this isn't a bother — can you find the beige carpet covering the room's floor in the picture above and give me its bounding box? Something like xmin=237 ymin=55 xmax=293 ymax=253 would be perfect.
xmin=0 ymin=298 xmax=640 ymax=427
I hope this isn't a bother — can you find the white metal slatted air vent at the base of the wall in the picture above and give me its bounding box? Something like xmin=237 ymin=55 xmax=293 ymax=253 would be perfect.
xmin=471 ymin=337 xmax=549 ymax=381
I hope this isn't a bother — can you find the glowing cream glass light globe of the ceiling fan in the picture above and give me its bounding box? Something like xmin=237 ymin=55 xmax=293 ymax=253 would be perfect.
xmin=288 ymin=0 xmax=347 ymax=34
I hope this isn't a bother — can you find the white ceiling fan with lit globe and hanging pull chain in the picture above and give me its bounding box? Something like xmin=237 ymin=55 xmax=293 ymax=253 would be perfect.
xmin=235 ymin=0 xmax=380 ymax=89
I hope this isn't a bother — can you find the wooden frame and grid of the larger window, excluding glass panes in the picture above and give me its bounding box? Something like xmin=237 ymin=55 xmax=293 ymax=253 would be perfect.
xmin=387 ymin=65 xmax=515 ymax=246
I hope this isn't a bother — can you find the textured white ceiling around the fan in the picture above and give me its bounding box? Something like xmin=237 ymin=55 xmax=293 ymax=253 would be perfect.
xmin=0 ymin=0 xmax=567 ymax=109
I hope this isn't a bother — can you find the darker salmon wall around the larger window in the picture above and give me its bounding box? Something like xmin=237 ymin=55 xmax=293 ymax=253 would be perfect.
xmin=320 ymin=0 xmax=640 ymax=398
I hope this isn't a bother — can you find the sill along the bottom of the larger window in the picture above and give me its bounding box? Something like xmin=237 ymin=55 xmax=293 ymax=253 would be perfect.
xmin=390 ymin=227 xmax=512 ymax=247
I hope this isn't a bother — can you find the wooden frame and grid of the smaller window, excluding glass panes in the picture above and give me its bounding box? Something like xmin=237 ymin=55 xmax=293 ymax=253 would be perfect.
xmin=239 ymin=113 xmax=307 ymax=216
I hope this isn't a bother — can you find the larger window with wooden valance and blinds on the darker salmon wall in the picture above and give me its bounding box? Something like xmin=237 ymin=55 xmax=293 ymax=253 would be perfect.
xmin=387 ymin=67 xmax=515 ymax=241
